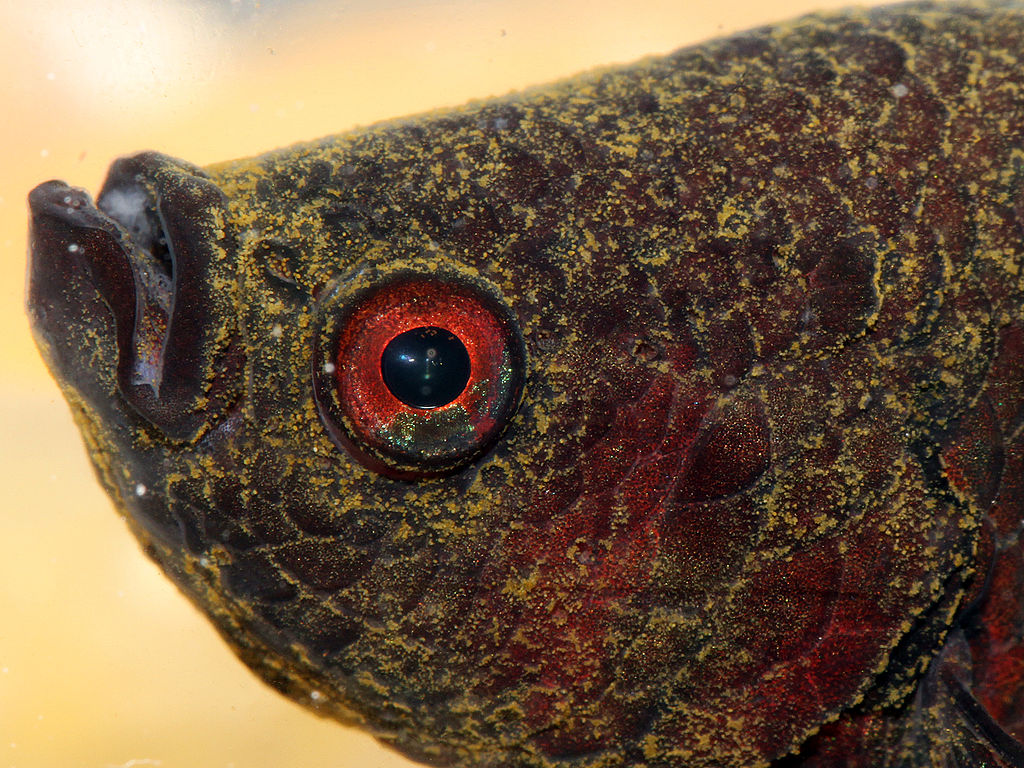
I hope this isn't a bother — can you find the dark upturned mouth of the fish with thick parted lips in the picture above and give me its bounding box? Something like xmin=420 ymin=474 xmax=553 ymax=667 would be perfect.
xmin=28 ymin=153 xmax=241 ymax=440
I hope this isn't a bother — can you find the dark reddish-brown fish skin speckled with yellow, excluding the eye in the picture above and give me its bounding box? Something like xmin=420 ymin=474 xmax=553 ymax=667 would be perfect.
xmin=22 ymin=5 xmax=1024 ymax=768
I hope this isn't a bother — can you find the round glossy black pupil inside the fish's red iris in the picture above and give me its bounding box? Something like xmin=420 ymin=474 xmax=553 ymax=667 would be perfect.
xmin=381 ymin=326 xmax=469 ymax=408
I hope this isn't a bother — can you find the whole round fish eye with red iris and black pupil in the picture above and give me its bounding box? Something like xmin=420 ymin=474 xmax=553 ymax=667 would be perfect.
xmin=312 ymin=271 xmax=525 ymax=477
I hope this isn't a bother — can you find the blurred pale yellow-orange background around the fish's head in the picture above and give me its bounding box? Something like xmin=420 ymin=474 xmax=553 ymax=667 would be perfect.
xmin=0 ymin=0 xmax=888 ymax=768
